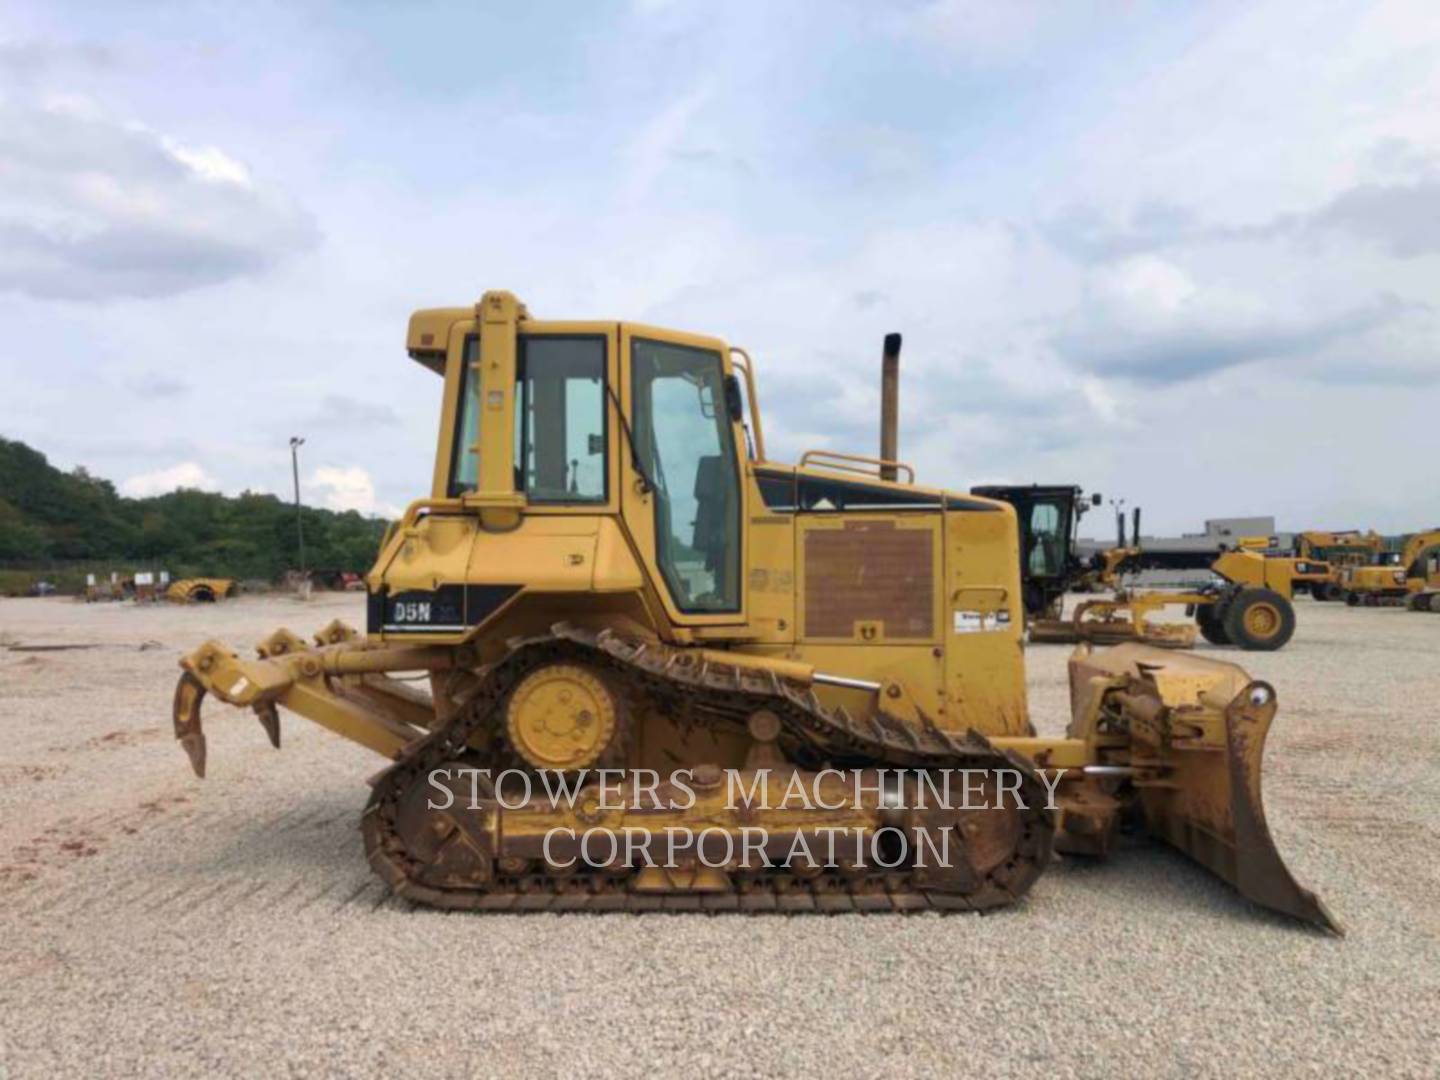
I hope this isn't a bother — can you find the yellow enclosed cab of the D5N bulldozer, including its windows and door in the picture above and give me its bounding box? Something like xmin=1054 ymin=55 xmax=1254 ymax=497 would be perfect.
xmin=391 ymin=292 xmax=747 ymax=638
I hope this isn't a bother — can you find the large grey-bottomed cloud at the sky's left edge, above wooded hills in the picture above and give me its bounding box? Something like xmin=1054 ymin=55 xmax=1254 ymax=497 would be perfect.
xmin=0 ymin=95 xmax=318 ymax=300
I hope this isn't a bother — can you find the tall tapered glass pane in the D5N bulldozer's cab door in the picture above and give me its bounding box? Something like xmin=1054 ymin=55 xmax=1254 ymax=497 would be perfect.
xmin=631 ymin=338 xmax=740 ymax=613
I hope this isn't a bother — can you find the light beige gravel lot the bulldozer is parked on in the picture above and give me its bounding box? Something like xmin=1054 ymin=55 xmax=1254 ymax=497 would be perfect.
xmin=0 ymin=596 xmax=1440 ymax=1077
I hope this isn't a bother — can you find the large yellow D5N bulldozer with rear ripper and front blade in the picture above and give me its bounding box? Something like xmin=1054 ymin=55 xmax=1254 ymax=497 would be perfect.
xmin=174 ymin=291 xmax=1338 ymax=932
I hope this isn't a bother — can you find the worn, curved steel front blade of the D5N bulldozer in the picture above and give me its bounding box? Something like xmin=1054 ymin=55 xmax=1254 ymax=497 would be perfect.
xmin=1071 ymin=645 xmax=1344 ymax=935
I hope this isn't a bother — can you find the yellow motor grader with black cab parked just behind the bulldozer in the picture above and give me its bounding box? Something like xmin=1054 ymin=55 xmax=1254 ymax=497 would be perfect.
xmin=971 ymin=484 xmax=1331 ymax=651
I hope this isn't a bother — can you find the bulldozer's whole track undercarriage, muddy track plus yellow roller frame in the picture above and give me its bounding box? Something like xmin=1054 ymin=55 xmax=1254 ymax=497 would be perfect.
xmin=364 ymin=626 xmax=1054 ymax=912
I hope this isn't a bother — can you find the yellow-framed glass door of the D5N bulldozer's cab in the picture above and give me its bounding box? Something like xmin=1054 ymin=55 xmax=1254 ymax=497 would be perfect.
xmin=621 ymin=324 xmax=747 ymax=628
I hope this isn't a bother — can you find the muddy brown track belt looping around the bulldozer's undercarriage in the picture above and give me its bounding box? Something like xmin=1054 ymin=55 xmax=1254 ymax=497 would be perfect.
xmin=361 ymin=624 xmax=1054 ymax=914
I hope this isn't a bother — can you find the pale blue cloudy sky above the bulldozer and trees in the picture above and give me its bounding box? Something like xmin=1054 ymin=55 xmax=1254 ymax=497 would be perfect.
xmin=0 ymin=0 xmax=1440 ymax=531
